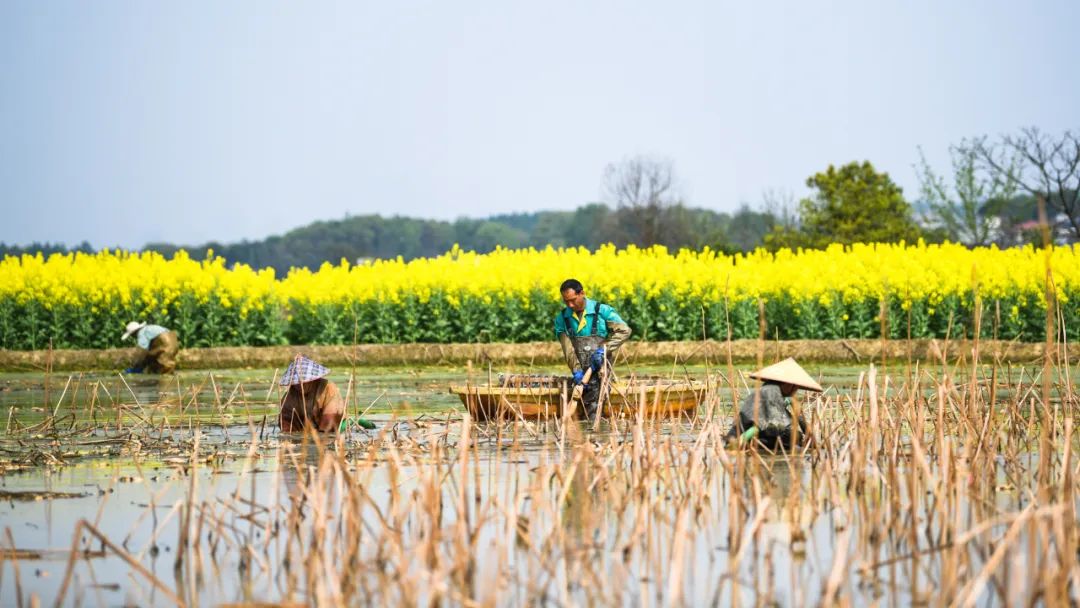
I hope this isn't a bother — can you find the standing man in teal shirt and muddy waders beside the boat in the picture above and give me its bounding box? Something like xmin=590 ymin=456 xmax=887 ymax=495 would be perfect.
xmin=555 ymin=279 xmax=631 ymax=418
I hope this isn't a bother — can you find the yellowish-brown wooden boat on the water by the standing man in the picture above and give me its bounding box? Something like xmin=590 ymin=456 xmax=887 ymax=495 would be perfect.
xmin=450 ymin=374 xmax=705 ymax=420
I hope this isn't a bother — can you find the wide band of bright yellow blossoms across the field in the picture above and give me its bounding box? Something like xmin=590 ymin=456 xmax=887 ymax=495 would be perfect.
xmin=0 ymin=242 xmax=1080 ymax=347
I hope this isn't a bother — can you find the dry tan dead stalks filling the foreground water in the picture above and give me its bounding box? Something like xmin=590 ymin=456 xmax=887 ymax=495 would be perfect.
xmin=0 ymin=347 xmax=1062 ymax=606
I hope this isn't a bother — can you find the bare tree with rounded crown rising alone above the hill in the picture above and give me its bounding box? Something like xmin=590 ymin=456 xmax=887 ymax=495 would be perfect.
xmin=604 ymin=156 xmax=681 ymax=246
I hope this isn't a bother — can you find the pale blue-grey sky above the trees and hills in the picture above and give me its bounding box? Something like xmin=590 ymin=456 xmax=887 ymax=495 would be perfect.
xmin=0 ymin=0 xmax=1080 ymax=247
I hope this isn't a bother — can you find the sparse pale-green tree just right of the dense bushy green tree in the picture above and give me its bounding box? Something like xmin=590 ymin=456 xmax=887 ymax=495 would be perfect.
xmin=915 ymin=139 xmax=1021 ymax=247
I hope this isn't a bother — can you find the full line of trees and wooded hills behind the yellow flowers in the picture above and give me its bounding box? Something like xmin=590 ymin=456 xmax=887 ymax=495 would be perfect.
xmin=0 ymin=127 xmax=1080 ymax=273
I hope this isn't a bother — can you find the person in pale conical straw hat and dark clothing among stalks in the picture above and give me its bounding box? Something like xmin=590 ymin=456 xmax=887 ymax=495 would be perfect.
xmin=728 ymin=357 xmax=822 ymax=448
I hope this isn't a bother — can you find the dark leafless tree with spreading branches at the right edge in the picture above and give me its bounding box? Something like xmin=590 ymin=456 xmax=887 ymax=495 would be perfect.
xmin=974 ymin=126 xmax=1080 ymax=240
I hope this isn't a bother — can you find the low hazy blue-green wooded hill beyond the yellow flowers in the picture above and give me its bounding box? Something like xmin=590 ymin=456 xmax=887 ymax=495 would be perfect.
xmin=0 ymin=203 xmax=774 ymax=273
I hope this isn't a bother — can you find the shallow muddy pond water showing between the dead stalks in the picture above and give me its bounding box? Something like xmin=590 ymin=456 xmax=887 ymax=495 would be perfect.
xmin=0 ymin=369 xmax=1075 ymax=606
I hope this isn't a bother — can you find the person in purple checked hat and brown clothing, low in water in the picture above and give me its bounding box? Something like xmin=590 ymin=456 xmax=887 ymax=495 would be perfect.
xmin=279 ymin=354 xmax=345 ymax=433
